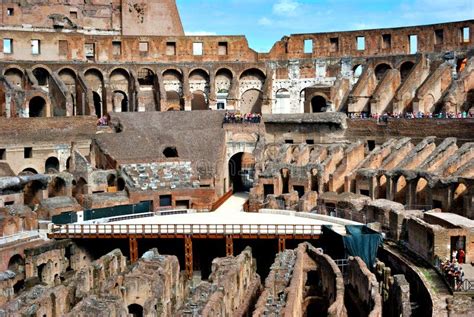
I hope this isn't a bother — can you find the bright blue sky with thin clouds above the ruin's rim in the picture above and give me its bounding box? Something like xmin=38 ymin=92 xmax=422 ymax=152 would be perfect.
xmin=176 ymin=0 xmax=474 ymax=52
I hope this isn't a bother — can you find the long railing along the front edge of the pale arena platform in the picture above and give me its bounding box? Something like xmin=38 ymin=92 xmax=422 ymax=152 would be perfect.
xmin=49 ymin=224 xmax=321 ymax=236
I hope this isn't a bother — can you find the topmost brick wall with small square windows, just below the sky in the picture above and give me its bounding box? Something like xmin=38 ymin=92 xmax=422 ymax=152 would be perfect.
xmin=0 ymin=20 xmax=474 ymax=63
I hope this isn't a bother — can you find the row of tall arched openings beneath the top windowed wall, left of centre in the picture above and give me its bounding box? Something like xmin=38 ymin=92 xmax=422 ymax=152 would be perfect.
xmin=4 ymin=66 xmax=266 ymax=117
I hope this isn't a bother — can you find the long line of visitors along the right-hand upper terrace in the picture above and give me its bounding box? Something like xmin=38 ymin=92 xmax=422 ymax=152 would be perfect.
xmin=349 ymin=111 xmax=474 ymax=122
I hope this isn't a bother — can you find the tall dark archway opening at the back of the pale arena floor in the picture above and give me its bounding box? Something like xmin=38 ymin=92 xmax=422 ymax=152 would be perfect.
xmin=229 ymin=152 xmax=255 ymax=193
